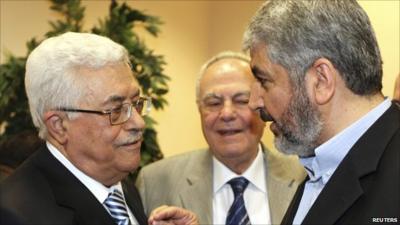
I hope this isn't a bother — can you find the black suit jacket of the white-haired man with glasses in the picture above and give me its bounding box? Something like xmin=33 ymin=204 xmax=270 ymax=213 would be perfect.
xmin=0 ymin=146 xmax=147 ymax=225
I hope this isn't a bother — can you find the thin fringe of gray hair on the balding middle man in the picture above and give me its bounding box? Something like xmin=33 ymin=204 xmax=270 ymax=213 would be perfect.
xmin=196 ymin=51 xmax=250 ymax=103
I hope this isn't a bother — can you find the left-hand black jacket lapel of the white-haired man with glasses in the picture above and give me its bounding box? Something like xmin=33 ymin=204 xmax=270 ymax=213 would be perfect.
xmin=37 ymin=148 xmax=115 ymax=225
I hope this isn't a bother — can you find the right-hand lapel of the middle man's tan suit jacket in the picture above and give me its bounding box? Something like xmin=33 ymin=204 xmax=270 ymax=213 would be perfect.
xmin=264 ymin=151 xmax=304 ymax=224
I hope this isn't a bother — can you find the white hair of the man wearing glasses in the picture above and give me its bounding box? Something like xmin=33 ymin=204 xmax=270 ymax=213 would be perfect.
xmin=25 ymin=32 xmax=130 ymax=139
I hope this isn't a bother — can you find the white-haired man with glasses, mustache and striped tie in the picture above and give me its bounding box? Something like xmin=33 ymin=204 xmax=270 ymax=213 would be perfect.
xmin=0 ymin=32 xmax=196 ymax=225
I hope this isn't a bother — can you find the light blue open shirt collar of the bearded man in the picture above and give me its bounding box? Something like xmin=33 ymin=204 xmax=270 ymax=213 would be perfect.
xmin=300 ymin=98 xmax=391 ymax=184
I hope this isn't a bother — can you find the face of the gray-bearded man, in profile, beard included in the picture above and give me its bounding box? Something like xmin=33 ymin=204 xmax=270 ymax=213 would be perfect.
xmin=249 ymin=44 xmax=322 ymax=157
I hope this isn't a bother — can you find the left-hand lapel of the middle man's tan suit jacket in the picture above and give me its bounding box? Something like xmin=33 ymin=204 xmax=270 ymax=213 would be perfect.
xmin=179 ymin=151 xmax=213 ymax=224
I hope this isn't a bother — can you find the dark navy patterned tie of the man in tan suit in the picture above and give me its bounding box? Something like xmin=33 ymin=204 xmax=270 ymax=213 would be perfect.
xmin=226 ymin=177 xmax=251 ymax=225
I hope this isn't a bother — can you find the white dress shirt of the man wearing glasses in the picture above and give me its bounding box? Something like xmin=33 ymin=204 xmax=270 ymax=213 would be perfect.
xmin=46 ymin=142 xmax=139 ymax=225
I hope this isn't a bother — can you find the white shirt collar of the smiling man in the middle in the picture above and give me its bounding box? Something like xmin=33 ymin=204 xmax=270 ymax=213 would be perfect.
xmin=213 ymin=145 xmax=266 ymax=194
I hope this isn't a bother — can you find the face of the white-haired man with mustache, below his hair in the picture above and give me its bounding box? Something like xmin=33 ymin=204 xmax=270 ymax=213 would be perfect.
xmin=64 ymin=64 xmax=145 ymax=186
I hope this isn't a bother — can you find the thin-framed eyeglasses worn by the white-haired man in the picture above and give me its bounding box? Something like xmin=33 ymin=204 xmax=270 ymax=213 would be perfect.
xmin=57 ymin=96 xmax=151 ymax=125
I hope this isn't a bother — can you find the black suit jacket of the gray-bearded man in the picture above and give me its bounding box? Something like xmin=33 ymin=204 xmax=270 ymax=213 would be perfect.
xmin=282 ymin=103 xmax=400 ymax=224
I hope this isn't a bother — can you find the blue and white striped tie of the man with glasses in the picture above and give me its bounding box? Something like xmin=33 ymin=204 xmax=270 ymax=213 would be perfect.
xmin=104 ymin=189 xmax=131 ymax=225
